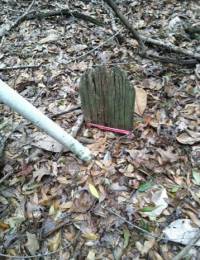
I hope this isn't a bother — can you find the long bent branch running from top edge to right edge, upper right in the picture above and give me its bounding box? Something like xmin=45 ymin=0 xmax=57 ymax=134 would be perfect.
xmin=104 ymin=0 xmax=200 ymax=61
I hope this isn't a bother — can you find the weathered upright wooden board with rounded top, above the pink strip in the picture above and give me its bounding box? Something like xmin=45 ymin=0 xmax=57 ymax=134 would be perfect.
xmin=80 ymin=66 xmax=135 ymax=130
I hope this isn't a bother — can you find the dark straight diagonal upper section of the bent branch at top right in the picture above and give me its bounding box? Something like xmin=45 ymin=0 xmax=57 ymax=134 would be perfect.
xmin=104 ymin=0 xmax=145 ymax=49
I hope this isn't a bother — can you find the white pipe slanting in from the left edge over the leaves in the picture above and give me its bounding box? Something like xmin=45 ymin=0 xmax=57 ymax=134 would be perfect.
xmin=0 ymin=80 xmax=92 ymax=161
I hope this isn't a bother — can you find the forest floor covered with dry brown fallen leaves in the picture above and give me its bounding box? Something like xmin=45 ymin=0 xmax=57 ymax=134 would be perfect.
xmin=0 ymin=0 xmax=200 ymax=260
